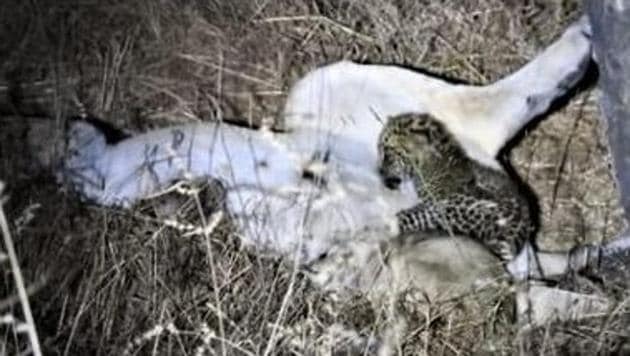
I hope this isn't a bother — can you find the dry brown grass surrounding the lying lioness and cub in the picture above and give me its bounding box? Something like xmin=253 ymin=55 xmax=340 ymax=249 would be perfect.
xmin=0 ymin=0 xmax=630 ymax=355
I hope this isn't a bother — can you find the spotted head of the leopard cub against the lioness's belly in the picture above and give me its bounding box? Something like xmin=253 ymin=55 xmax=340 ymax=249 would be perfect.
xmin=378 ymin=114 xmax=450 ymax=189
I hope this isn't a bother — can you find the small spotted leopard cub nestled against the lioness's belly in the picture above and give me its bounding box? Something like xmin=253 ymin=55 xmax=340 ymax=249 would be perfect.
xmin=378 ymin=114 xmax=536 ymax=262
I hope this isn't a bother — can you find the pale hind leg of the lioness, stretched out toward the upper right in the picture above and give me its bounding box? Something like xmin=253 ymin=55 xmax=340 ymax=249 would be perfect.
xmin=442 ymin=17 xmax=591 ymax=157
